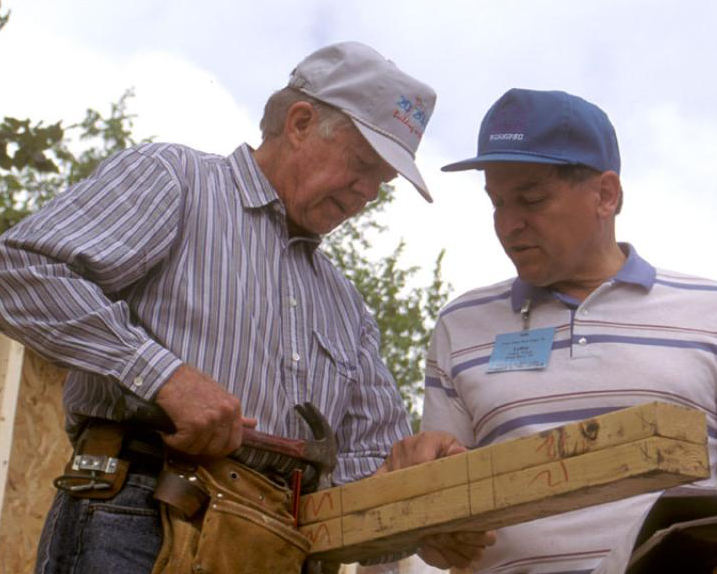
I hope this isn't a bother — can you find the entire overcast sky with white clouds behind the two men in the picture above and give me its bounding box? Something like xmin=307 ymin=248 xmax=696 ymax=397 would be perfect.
xmin=0 ymin=0 xmax=717 ymax=295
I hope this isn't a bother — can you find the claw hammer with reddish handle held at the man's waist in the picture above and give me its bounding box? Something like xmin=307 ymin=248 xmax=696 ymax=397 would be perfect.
xmin=113 ymin=392 xmax=337 ymax=487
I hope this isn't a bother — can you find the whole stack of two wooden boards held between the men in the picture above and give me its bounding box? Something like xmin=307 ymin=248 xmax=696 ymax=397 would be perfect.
xmin=299 ymin=403 xmax=709 ymax=562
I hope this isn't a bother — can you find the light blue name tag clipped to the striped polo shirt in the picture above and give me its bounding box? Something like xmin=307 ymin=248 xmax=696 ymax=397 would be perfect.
xmin=487 ymin=327 xmax=555 ymax=373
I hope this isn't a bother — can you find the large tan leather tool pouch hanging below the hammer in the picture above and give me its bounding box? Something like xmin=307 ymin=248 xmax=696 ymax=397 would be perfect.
xmin=152 ymin=459 xmax=310 ymax=574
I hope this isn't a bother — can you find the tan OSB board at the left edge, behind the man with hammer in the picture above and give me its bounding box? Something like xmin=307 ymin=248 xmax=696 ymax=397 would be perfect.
xmin=0 ymin=349 xmax=71 ymax=574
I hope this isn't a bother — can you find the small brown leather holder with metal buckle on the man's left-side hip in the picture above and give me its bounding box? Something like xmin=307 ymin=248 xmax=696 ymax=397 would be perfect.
xmin=54 ymin=419 xmax=129 ymax=499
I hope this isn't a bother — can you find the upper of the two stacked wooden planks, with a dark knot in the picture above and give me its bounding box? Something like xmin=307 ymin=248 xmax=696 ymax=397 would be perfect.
xmin=299 ymin=402 xmax=707 ymax=525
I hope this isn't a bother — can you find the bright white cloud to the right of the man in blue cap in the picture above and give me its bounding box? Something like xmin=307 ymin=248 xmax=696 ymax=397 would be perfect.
xmin=618 ymin=102 xmax=717 ymax=278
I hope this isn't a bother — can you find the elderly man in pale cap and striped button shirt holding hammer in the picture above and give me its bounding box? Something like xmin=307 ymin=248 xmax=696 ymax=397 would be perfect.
xmin=0 ymin=42 xmax=492 ymax=574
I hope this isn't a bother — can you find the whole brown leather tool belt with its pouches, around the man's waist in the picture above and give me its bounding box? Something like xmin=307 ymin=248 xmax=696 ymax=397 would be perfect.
xmin=54 ymin=419 xmax=311 ymax=574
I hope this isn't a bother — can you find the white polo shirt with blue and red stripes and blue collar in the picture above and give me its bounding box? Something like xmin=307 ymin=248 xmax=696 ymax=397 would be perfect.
xmin=423 ymin=244 xmax=717 ymax=574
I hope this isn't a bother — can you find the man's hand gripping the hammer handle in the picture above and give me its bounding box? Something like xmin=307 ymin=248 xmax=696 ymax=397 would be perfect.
xmin=155 ymin=364 xmax=250 ymax=457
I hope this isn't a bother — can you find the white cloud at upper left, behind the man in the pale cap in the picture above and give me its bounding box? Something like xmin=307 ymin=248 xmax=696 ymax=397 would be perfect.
xmin=0 ymin=7 xmax=259 ymax=154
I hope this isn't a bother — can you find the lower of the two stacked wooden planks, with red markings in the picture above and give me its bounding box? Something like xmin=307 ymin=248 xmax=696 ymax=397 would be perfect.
xmin=301 ymin=437 xmax=709 ymax=562
